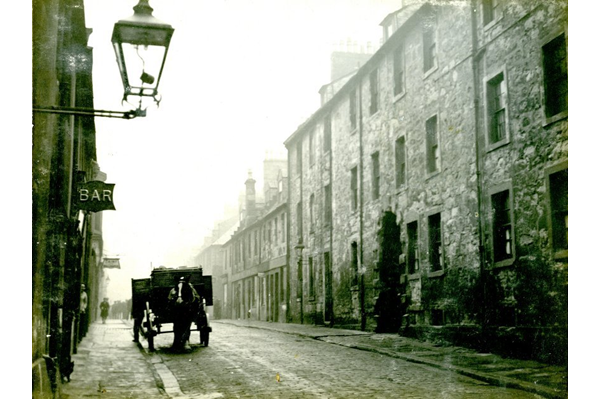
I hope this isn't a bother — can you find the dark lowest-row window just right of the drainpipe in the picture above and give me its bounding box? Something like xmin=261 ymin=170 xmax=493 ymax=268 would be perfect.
xmin=492 ymin=190 xmax=514 ymax=262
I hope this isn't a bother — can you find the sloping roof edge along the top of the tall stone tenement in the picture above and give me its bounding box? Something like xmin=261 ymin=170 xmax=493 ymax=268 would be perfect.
xmin=283 ymin=2 xmax=432 ymax=147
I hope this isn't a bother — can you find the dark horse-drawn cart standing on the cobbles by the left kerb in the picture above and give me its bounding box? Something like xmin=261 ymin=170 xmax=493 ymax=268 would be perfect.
xmin=131 ymin=267 xmax=213 ymax=350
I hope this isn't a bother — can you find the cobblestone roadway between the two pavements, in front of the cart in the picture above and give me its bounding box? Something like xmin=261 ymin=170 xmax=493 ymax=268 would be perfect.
xmin=145 ymin=321 xmax=541 ymax=399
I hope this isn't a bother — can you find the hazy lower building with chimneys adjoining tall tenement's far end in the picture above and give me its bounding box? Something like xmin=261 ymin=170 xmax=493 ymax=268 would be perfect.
xmin=217 ymin=158 xmax=288 ymax=322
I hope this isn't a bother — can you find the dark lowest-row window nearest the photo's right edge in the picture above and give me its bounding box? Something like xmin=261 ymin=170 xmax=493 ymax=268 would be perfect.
xmin=549 ymin=169 xmax=569 ymax=252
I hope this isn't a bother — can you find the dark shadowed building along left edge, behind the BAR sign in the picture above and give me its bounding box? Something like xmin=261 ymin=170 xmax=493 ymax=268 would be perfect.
xmin=31 ymin=0 xmax=103 ymax=398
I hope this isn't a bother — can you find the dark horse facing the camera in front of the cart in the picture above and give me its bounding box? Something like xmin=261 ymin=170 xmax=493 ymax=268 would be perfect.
xmin=168 ymin=276 xmax=201 ymax=350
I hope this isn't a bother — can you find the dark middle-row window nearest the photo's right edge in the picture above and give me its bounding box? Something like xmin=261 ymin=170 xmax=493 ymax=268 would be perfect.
xmin=542 ymin=34 xmax=569 ymax=117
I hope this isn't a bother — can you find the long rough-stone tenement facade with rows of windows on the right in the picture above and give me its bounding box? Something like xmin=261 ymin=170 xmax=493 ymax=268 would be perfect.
xmin=285 ymin=0 xmax=568 ymax=362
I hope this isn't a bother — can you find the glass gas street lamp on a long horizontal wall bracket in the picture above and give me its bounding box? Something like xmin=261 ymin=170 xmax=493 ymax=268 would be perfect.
xmin=33 ymin=0 xmax=175 ymax=119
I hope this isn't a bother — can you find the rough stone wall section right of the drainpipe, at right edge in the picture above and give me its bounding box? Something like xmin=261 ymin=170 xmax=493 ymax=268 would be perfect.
xmin=473 ymin=1 xmax=569 ymax=361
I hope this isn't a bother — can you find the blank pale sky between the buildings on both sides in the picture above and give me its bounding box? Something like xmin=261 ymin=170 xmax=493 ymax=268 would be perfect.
xmin=84 ymin=0 xmax=401 ymax=301
